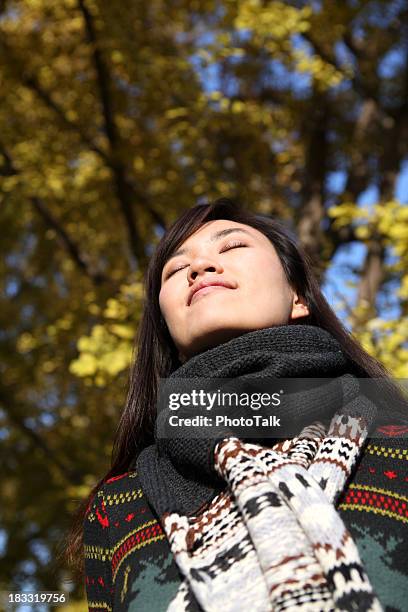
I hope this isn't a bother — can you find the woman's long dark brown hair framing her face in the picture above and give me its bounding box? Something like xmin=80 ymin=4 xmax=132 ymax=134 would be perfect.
xmin=63 ymin=198 xmax=405 ymax=577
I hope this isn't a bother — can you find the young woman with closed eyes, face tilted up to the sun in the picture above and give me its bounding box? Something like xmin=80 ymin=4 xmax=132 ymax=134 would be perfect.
xmin=63 ymin=199 xmax=408 ymax=612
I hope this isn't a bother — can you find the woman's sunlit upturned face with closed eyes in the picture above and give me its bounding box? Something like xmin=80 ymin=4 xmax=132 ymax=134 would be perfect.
xmin=159 ymin=219 xmax=309 ymax=362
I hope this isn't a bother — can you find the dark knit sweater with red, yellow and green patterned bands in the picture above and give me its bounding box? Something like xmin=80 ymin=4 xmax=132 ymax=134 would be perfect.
xmin=84 ymin=425 xmax=408 ymax=612
